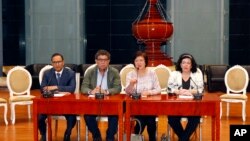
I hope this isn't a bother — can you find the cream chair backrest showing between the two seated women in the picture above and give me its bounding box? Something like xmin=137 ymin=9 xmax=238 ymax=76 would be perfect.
xmin=153 ymin=64 xmax=171 ymax=93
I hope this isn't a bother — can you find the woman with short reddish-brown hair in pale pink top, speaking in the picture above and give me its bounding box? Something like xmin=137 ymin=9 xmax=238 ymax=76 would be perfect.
xmin=125 ymin=51 xmax=161 ymax=141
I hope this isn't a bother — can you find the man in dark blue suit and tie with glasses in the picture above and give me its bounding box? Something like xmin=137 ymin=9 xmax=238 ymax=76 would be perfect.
xmin=38 ymin=53 xmax=76 ymax=141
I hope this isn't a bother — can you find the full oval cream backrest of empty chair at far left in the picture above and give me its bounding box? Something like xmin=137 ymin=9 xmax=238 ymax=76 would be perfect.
xmin=7 ymin=66 xmax=32 ymax=97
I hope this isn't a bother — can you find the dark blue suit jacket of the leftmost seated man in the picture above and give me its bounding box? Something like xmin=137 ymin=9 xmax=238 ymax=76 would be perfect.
xmin=41 ymin=68 xmax=76 ymax=93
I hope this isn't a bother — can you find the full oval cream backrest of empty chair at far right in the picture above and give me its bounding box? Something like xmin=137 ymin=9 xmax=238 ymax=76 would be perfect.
xmin=224 ymin=65 xmax=249 ymax=95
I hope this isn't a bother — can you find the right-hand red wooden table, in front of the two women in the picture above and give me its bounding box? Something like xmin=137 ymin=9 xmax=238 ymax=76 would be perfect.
xmin=125 ymin=94 xmax=220 ymax=141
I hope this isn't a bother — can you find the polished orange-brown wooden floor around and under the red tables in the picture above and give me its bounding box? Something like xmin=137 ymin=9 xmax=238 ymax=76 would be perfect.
xmin=0 ymin=88 xmax=250 ymax=141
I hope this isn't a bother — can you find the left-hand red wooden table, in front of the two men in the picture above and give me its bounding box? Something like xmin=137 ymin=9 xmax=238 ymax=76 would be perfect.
xmin=33 ymin=94 xmax=125 ymax=141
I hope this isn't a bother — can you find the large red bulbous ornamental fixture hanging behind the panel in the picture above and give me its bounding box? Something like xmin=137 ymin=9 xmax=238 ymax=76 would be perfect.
xmin=132 ymin=0 xmax=173 ymax=67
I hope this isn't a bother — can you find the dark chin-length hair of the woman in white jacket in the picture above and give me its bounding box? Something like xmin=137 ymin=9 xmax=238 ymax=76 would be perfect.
xmin=175 ymin=53 xmax=197 ymax=73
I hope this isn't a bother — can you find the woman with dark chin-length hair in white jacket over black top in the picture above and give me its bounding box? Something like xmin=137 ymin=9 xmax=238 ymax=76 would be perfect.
xmin=168 ymin=53 xmax=204 ymax=141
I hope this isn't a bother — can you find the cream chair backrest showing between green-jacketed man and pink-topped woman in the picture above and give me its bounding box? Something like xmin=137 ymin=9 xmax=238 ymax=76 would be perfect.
xmin=120 ymin=64 xmax=135 ymax=93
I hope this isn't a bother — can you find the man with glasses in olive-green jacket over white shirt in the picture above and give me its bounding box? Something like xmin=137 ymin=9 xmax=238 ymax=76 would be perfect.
xmin=81 ymin=50 xmax=121 ymax=141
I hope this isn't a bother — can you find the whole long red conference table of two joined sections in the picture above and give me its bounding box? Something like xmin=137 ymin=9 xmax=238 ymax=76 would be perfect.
xmin=33 ymin=94 xmax=220 ymax=141
